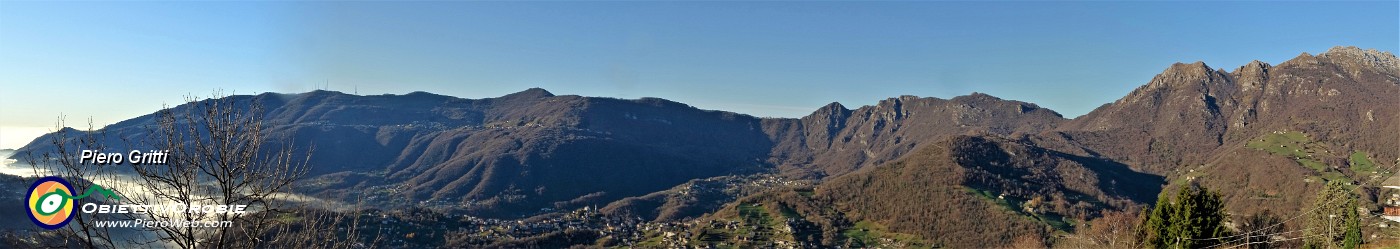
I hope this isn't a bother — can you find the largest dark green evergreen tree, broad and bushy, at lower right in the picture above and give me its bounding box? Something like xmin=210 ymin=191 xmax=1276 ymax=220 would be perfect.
xmin=1142 ymin=185 xmax=1226 ymax=249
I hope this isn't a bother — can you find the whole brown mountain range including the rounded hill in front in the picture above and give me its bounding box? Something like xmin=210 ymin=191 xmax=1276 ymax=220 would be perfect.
xmin=18 ymin=48 xmax=1400 ymax=248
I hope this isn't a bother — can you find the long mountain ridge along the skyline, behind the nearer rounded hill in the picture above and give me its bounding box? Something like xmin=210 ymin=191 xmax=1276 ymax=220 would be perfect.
xmin=13 ymin=48 xmax=1400 ymax=228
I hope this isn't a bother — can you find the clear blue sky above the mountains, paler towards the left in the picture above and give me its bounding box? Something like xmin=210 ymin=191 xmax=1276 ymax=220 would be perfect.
xmin=0 ymin=1 xmax=1400 ymax=148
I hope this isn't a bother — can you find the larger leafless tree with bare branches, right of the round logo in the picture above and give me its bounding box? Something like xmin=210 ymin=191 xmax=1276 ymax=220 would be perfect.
xmin=132 ymin=91 xmax=311 ymax=248
